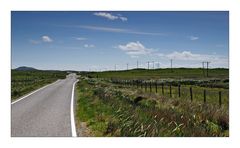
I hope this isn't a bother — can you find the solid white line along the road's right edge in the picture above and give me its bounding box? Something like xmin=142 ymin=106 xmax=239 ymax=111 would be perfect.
xmin=70 ymin=80 xmax=78 ymax=137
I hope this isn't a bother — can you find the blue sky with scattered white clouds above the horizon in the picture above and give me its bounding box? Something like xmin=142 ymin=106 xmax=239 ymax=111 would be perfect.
xmin=12 ymin=11 xmax=229 ymax=71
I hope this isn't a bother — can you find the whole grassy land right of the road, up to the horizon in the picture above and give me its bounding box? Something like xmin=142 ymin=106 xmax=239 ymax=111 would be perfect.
xmin=76 ymin=68 xmax=229 ymax=137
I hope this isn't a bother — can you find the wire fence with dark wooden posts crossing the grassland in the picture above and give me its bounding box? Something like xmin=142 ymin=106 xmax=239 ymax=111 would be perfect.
xmin=110 ymin=79 xmax=229 ymax=107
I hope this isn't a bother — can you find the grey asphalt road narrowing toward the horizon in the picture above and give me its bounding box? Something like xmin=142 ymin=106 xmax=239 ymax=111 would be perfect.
xmin=11 ymin=74 xmax=77 ymax=137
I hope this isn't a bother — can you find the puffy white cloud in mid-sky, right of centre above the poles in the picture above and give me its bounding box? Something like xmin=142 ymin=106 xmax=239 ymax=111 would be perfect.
xmin=118 ymin=41 xmax=153 ymax=58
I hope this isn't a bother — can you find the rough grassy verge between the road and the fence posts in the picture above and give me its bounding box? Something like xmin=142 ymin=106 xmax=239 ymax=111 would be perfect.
xmin=76 ymin=77 xmax=229 ymax=137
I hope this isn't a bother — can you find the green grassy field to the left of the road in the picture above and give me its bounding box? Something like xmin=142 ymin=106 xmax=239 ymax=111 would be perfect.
xmin=11 ymin=70 xmax=66 ymax=100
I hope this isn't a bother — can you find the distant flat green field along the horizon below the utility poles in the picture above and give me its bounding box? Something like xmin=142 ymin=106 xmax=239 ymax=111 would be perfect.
xmin=85 ymin=68 xmax=229 ymax=80
